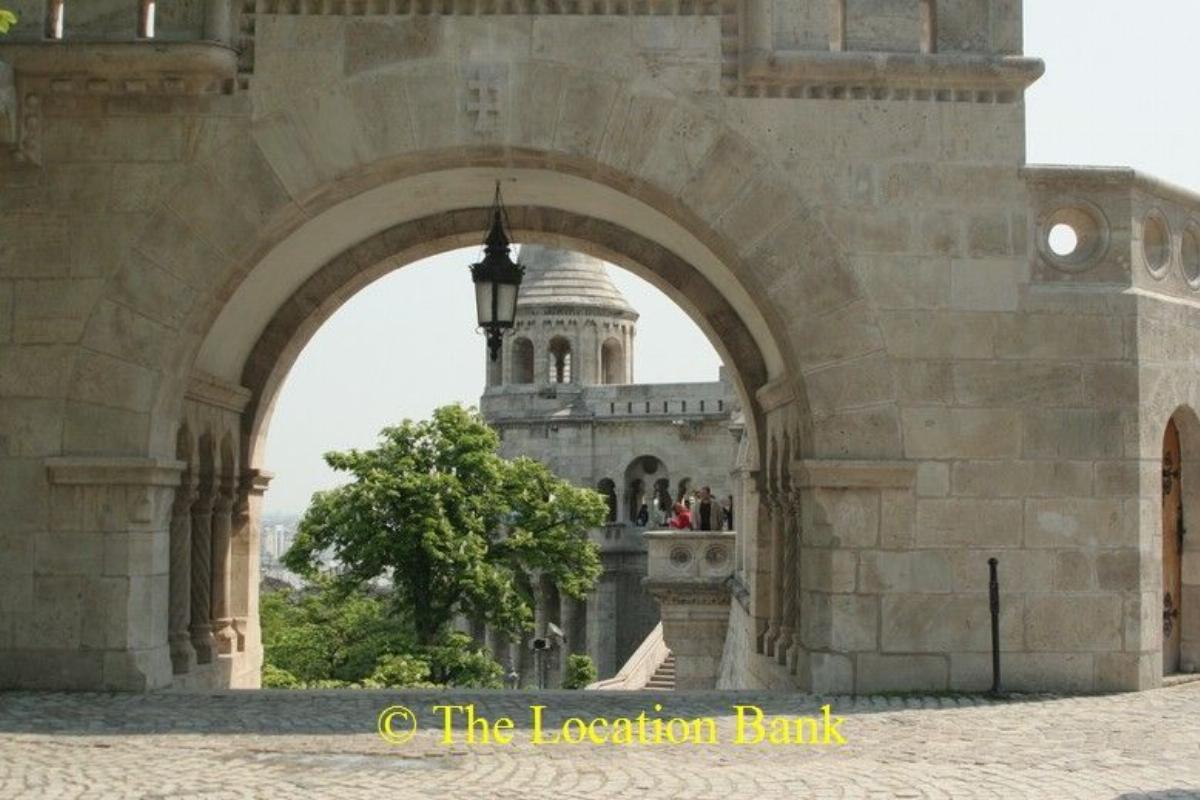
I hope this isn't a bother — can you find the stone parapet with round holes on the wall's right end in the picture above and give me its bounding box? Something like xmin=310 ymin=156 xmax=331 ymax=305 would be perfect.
xmin=1024 ymin=167 xmax=1200 ymax=300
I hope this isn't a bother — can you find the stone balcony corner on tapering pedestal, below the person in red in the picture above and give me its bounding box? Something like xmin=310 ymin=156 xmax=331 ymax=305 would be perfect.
xmin=646 ymin=531 xmax=737 ymax=690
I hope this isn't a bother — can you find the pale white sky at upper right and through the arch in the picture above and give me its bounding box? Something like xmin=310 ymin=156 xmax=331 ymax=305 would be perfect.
xmin=265 ymin=0 xmax=1200 ymax=515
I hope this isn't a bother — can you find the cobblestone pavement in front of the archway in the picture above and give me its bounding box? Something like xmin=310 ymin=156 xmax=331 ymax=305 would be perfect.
xmin=0 ymin=684 xmax=1200 ymax=800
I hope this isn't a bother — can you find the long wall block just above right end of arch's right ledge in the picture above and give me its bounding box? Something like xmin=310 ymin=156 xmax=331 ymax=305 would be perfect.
xmin=900 ymin=408 xmax=1021 ymax=458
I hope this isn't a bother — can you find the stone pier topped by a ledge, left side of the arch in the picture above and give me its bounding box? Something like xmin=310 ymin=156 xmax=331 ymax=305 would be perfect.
xmin=35 ymin=457 xmax=184 ymax=692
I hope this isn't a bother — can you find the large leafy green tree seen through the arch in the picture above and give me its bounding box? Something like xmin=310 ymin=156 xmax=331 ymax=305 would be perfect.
xmin=283 ymin=405 xmax=607 ymax=652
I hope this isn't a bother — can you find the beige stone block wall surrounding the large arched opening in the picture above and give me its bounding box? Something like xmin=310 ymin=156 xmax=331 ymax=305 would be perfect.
xmin=0 ymin=0 xmax=1200 ymax=691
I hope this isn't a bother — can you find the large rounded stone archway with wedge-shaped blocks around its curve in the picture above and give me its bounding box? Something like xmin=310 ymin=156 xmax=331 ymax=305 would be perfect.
xmin=54 ymin=72 xmax=900 ymax=686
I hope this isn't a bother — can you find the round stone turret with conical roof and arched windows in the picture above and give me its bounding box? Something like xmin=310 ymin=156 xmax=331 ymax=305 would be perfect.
xmin=487 ymin=245 xmax=637 ymax=391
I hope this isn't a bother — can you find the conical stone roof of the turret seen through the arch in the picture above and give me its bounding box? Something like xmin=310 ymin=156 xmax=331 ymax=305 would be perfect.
xmin=517 ymin=245 xmax=637 ymax=318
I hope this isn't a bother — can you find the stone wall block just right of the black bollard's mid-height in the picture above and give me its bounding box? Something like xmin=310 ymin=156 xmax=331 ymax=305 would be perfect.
xmin=1024 ymin=594 xmax=1122 ymax=652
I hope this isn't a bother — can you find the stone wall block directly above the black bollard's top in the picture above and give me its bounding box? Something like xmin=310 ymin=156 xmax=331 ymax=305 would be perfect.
xmin=917 ymin=499 xmax=1021 ymax=547
